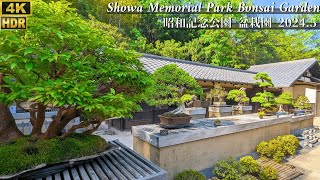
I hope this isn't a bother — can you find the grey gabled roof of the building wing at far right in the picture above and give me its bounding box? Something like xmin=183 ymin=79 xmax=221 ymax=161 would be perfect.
xmin=248 ymin=58 xmax=318 ymax=87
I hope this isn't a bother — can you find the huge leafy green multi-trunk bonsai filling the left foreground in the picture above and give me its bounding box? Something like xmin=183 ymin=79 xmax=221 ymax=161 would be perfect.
xmin=0 ymin=0 xmax=150 ymax=141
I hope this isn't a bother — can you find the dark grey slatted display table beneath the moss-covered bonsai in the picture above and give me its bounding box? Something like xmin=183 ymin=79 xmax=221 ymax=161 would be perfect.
xmin=14 ymin=140 xmax=168 ymax=180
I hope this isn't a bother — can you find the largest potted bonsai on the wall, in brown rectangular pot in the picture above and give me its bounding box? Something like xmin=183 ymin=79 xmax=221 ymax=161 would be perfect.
xmin=147 ymin=64 xmax=202 ymax=126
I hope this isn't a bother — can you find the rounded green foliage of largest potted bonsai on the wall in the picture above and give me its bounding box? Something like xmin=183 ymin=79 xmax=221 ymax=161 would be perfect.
xmin=147 ymin=64 xmax=202 ymax=106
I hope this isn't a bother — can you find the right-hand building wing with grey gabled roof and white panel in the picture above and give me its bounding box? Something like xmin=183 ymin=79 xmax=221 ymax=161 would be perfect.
xmin=248 ymin=58 xmax=320 ymax=116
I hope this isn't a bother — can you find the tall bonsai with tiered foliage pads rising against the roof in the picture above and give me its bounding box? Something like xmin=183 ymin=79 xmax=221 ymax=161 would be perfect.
xmin=251 ymin=72 xmax=276 ymax=114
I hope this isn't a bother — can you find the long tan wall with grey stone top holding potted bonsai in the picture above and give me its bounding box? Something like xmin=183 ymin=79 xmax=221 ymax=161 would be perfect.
xmin=132 ymin=115 xmax=313 ymax=179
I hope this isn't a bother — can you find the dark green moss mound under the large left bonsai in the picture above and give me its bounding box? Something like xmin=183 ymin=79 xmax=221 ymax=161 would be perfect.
xmin=0 ymin=134 xmax=107 ymax=175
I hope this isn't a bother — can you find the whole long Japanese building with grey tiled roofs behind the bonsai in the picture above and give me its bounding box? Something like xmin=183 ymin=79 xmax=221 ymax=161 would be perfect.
xmin=113 ymin=54 xmax=320 ymax=129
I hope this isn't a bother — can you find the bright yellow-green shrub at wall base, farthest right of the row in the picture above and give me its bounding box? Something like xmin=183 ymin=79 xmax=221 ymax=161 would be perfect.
xmin=256 ymin=135 xmax=299 ymax=162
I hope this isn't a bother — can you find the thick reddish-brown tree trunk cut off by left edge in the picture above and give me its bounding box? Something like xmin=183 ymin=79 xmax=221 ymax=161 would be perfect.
xmin=0 ymin=73 xmax=23 ymax=142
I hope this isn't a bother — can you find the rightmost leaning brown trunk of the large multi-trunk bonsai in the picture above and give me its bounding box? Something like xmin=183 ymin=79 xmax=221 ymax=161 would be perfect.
xmin=45 ymin=106 xmax=80 ymax=139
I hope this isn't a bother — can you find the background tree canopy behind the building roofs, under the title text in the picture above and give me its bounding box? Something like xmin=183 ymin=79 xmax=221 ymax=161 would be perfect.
xmin=41 ymin=0 xmax=320 ymax=69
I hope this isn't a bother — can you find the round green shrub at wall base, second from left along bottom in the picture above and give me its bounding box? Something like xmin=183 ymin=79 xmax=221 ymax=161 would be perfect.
xmin=212 ymin=158 xmax=245 ymax=180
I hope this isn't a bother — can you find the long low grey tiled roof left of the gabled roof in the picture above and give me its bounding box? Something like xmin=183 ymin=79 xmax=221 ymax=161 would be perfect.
xmin=140 ymin=54 xmax=256 ymax=84
